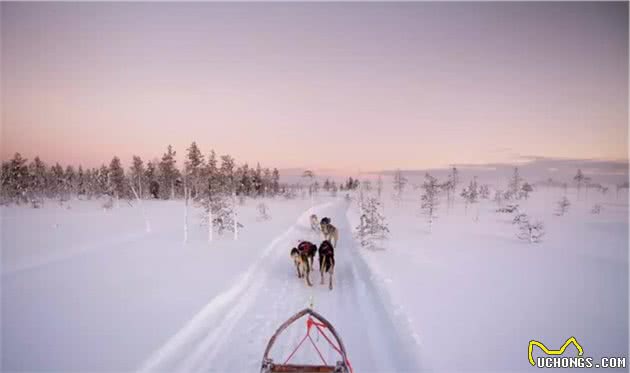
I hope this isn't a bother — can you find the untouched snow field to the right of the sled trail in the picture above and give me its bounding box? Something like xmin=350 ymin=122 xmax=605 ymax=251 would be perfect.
xmin=349 ymin=188 xmax=628 ymax=371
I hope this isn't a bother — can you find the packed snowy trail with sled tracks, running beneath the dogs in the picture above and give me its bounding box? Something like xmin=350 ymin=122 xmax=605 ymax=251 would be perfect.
xmin=140 ymin=201 xmax=421 ymax=372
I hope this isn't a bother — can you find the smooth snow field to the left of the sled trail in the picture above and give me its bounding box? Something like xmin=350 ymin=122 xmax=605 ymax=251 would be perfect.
xmin=2 ymin=199 xmax=310 ymax=371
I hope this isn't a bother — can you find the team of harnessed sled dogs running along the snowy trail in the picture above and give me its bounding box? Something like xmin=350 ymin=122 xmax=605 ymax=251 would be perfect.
xmin=291 ymin=214 xmax=339 ymax=290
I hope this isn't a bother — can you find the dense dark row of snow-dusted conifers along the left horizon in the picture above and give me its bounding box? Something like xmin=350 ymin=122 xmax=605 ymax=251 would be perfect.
xmin=0 ymin=142 xmax=285 ymax=205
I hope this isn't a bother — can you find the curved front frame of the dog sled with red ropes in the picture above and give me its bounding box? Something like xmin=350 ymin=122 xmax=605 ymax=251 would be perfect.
xmin=260 ymin=308 xmax=353 ymax=373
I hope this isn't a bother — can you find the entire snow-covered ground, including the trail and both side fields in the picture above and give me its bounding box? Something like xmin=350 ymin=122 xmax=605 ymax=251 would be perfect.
xmin=2 ymin=185 xmax=628 ymax=372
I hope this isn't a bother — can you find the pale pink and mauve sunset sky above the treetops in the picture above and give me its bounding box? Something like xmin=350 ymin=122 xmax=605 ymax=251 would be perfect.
xmin=0 ymin=2 xmax=628 ymax=170
